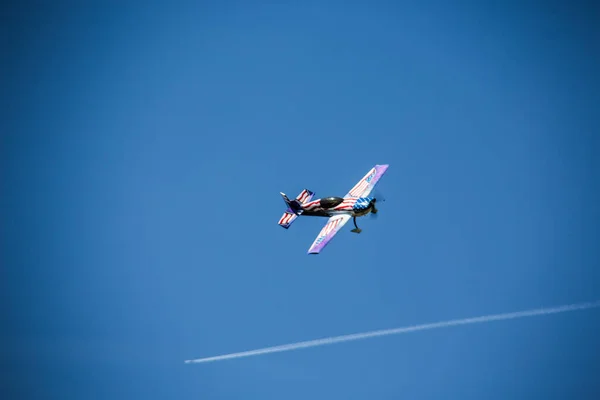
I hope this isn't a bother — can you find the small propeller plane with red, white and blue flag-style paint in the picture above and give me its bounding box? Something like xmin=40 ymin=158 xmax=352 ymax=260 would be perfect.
xmin=279 ymin=164 xmax=389 ymax=254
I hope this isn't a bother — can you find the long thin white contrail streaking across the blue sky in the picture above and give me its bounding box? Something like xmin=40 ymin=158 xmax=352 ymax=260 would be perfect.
xmin=185 ymin=301 xmax=600 ymax=364
